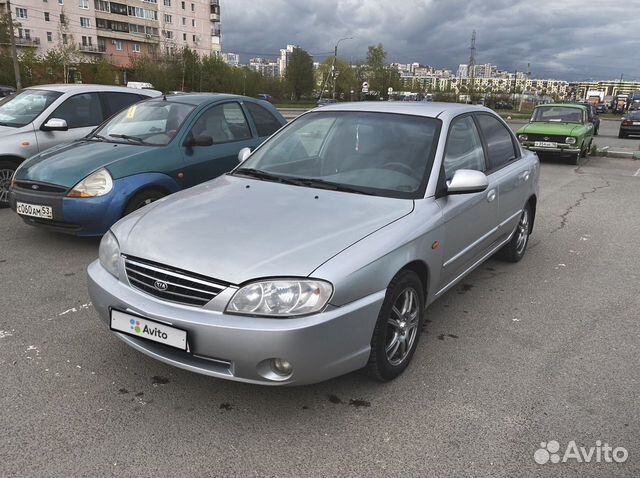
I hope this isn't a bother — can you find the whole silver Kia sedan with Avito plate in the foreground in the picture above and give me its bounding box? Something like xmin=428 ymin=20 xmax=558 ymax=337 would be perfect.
xmin=89 ymin=103 xmax=539 ymax=385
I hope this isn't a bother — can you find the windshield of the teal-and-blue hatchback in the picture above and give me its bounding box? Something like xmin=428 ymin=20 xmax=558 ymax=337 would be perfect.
xmin=93 ymin=100 xmax=194 ymax=146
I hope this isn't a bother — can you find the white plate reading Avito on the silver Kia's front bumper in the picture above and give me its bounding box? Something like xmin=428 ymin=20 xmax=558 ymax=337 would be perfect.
xmin=111 ymin=309 xmax=188 ymax=351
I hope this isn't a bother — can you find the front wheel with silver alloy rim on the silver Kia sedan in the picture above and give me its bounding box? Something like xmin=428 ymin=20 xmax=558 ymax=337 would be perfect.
xmin=366 ymin=270 xmax=424 ymax=382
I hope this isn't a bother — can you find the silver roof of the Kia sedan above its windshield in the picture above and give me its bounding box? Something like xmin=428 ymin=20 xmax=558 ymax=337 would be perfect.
xmin=313 ymin=101 xmax=495 ymax=118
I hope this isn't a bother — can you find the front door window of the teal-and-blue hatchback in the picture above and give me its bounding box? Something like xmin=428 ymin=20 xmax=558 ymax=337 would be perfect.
xmin=191 ymin=103 xmax=251 ymax=144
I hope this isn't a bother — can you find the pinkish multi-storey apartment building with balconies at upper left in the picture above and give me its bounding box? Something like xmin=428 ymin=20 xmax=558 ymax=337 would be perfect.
xmin=0 ymin=0 xmax=221 ymax=67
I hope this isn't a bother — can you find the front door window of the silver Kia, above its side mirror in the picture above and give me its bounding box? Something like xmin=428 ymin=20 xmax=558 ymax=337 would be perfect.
xmin=444 ymin=116 xmax=486 ymax=181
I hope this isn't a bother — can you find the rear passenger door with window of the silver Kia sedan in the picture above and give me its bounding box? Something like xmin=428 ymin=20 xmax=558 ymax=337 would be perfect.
xmin=476 ymin=113 xmax=533 ymax=240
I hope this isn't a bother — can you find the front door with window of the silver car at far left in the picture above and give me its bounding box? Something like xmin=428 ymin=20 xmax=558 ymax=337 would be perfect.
xmin=36 ymin=93 xmax=104 ymax=151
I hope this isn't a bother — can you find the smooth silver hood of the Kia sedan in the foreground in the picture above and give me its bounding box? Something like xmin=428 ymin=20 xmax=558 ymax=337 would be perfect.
xmin=113 ymin=176 xmax=413 ymax=284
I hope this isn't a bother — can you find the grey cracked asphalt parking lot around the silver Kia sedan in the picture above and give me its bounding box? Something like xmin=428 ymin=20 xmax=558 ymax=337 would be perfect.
xmin=0 ymin=155 xmax=640 ymax=477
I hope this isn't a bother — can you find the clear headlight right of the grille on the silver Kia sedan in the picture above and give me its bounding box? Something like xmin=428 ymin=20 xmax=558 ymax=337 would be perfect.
xmin=227 ymin=279 xmax=333 ymax=317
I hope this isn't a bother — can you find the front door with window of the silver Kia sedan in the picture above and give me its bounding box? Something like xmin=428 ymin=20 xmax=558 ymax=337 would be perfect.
xmin=436 ymin=114 xmax=499 ymax=290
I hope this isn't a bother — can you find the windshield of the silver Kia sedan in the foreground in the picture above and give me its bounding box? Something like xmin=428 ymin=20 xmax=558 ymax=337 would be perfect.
xmin=234 ymin=111 xmax=440 ymax=198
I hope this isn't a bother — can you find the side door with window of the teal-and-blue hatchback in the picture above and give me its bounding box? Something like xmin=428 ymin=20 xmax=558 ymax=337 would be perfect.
xmin=183 ymin=101 xmax=260 ymax=187
